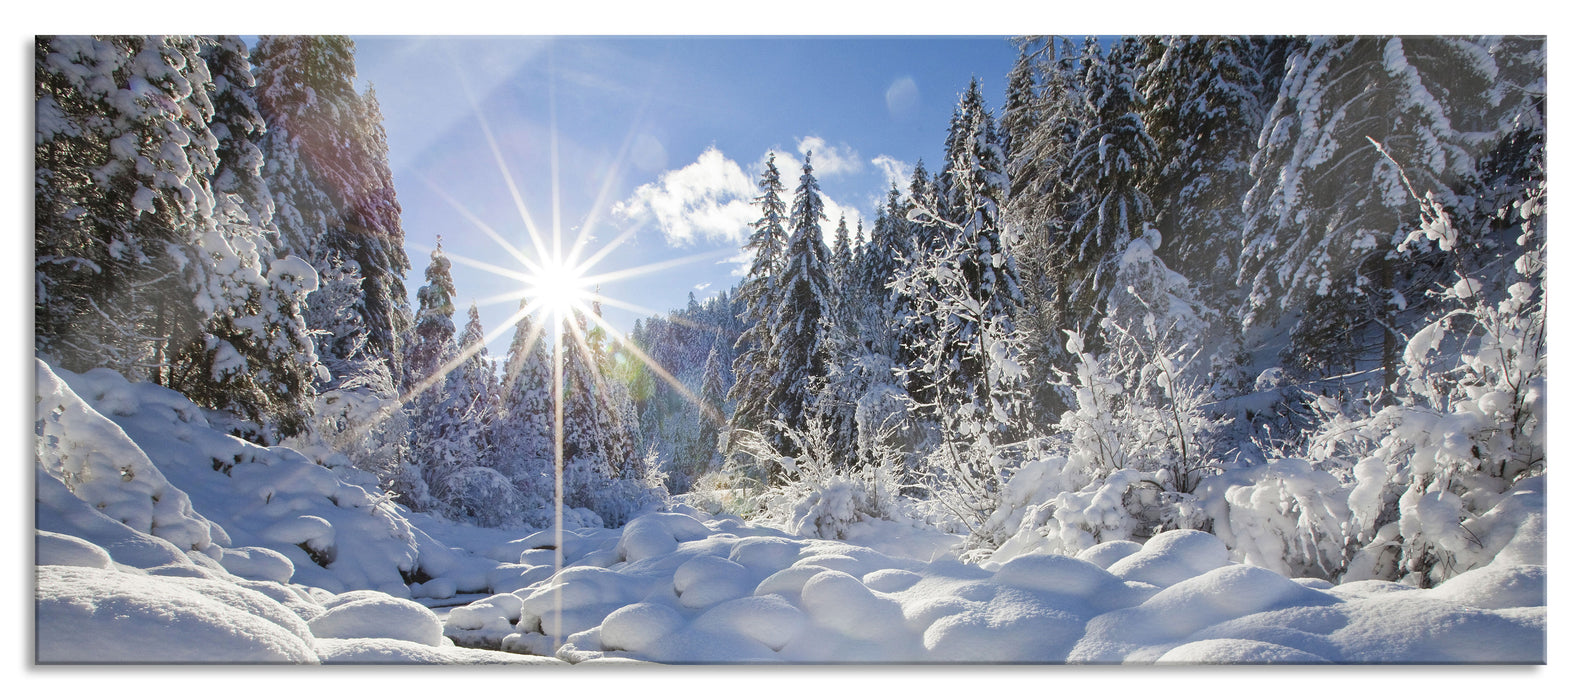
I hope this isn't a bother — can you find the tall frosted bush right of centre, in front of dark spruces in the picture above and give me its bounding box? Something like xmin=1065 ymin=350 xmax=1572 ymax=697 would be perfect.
xmin=987 ymin=234 xmax=1226 ymax=559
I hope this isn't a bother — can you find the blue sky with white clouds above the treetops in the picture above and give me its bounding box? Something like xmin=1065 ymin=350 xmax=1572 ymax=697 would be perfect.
xmin=346 ymin=36 xmax=1016 ymax=356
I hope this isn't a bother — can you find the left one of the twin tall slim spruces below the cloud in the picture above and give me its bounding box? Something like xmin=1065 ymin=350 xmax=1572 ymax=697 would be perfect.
xmin=726 ymin=152 xmax=786 ymax=456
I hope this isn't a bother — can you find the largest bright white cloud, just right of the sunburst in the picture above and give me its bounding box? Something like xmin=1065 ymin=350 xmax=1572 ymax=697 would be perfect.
xmin=615 ymin=146 xmax=758 ymax=245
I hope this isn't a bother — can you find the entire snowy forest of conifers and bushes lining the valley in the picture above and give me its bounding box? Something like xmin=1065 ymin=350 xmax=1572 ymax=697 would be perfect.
xmin=33 ymin=35 xmax=1549 ymax=662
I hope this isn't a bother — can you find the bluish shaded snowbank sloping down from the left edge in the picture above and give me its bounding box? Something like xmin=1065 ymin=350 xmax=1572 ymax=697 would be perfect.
xmin=33 ymin=361 xmax=520 ymax=597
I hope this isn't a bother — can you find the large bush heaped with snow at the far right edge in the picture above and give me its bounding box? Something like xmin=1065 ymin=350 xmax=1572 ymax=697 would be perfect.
xmin=1220 ymin=163 xmax=1547 ymax=586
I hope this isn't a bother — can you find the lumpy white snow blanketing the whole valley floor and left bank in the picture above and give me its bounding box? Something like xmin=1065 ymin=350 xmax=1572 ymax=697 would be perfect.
xmin=35 ymin=357 xmax=1552 ymax=664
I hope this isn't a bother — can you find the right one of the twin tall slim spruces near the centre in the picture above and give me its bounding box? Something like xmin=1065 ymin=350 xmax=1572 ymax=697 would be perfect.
xmin=769 ymin=150 xmax=834 ymax=477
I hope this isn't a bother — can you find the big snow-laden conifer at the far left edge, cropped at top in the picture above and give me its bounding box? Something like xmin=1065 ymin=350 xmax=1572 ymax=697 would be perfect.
xmin=33 ymin=36 xmax=217 ymax=383
